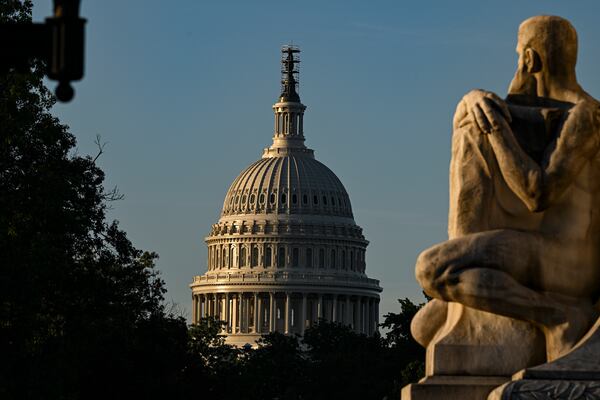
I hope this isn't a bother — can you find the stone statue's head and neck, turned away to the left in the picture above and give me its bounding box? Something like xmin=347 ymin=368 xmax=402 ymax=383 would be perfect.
xmin=509 ymin=15 xmax=577 ymax=96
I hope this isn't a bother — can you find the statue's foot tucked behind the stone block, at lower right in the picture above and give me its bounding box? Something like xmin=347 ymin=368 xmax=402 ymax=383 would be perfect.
xmin=544 ymin=302 xmax=598 ymax=362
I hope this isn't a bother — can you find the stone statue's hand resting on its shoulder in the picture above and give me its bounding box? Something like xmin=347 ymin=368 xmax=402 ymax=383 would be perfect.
xmin=454 ymin=89 xmax=511 ymax=133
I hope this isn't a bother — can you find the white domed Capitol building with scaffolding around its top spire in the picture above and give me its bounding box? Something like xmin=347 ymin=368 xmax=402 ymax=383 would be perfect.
xmin=190 ymin=46 xmax=382 ymax=346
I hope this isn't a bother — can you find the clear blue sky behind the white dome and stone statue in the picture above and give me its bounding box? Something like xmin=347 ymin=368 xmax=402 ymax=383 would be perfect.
xmin=34 ymin=0 xmax=600 ymax=322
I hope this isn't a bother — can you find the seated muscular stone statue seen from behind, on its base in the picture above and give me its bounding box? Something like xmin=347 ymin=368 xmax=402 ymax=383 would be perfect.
xmin=403 ymin=16 xmax=600 ymax=399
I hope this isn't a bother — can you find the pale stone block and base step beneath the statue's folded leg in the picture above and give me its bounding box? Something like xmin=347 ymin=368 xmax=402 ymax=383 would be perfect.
xmin=402 ymin=303 xmax=545 ymax=400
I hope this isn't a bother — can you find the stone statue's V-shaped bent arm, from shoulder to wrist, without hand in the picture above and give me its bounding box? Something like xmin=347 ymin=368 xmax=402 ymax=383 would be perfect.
xmin=489 ymin=102 xmax=600 ymax=212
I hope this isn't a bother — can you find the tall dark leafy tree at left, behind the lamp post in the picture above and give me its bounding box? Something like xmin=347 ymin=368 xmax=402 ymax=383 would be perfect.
xmin=0 ymin=0 xmax=187 ymax=399
